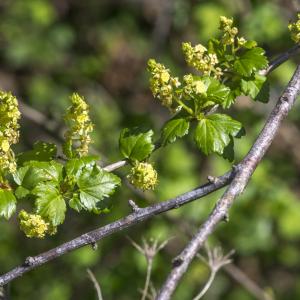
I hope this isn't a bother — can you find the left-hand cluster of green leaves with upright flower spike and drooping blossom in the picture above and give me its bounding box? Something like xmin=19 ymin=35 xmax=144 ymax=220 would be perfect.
xmin=0 ymin=94 xmax=120 ymax=238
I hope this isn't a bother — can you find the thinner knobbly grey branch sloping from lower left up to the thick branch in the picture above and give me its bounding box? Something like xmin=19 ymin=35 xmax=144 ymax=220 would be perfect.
xmin=0 ymin=169 xmax=236 ymax=286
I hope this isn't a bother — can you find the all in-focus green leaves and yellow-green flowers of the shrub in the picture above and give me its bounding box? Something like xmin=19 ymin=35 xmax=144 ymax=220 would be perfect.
xmin=0 ymin=15 xmax=300 ymax=238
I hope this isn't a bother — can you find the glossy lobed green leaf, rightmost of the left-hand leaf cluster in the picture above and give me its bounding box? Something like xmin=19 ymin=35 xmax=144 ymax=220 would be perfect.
xmin=77 ymin=166 xmax=121 ymax=211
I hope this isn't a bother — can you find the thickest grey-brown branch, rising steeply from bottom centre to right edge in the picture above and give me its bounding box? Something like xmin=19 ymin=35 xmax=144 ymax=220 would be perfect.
xmin=157 ymin=65 xmax=300 ymax=300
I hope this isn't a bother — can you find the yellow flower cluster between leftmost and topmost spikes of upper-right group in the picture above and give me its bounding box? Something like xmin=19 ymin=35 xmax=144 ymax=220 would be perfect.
xmin=182 ymin=43 xmax=222 ymax=75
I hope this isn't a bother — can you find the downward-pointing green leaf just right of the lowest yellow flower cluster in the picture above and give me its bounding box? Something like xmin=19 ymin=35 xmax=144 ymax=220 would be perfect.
xmin=32 ymin=181 xmax=66 ymax=226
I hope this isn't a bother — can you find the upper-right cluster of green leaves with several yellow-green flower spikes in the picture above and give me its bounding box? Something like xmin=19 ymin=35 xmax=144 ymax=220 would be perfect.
xmin=148 ymin=17 xmax=269 ymax=160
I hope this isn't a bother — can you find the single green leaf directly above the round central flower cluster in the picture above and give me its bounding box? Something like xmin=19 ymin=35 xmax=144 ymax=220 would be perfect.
xmin=119 ymin=128 xmax=154 ymax=161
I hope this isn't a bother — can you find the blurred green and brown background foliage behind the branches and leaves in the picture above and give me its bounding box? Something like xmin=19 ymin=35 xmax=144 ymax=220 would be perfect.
xmin=0 ymin=0 xmax=300 ymax=300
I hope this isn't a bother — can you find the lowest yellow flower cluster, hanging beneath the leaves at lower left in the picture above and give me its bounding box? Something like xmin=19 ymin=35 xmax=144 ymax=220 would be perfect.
xmin=19 ymin=210 xmax=49 ymax=239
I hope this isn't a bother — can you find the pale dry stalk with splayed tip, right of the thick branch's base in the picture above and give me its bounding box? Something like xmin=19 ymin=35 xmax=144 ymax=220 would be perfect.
xmin=193 ymin=245 xmax=234 ymax=300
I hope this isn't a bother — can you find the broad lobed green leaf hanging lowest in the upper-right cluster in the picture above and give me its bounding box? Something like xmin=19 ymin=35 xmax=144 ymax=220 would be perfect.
xmin=194 ymin=114 xmax=242 ymax=155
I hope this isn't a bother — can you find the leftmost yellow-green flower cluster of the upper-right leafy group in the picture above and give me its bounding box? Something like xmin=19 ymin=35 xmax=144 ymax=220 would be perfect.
xmin=148 ymin=59 xmax=180 ymax=110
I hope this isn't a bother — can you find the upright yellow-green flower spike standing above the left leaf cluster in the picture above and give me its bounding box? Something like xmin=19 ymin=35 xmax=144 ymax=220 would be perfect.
xmin=63 ymin=93 xmax=93 ymax=158
